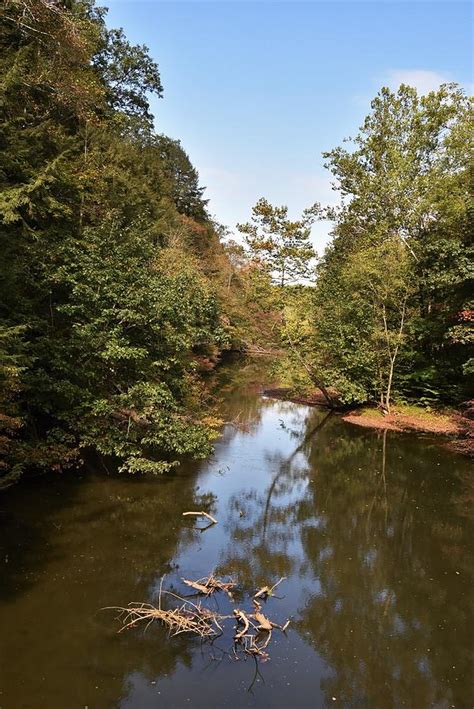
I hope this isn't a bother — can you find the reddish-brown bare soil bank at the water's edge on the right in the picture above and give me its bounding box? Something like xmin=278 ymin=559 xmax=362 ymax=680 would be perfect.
xmin=263 ymin=388 xmax=474 ymax=457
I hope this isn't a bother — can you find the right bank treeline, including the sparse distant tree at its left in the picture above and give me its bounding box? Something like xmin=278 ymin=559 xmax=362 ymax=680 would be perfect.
xmin=232 ymin=84 xmax=474 ymax=410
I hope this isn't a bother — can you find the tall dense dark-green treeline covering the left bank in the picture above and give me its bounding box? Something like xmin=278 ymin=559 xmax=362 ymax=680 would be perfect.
xmin=0 ymin=0 xmax=260 ymax=484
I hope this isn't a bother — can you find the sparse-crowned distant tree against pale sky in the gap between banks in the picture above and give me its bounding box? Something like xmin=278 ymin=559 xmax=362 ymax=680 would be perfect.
xmin=237 ymin=199 xmax=318 ymax=288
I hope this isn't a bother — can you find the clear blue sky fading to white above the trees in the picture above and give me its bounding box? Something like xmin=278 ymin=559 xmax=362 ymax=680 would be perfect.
xmin=105 ymin=0 xmax=473 ymax=252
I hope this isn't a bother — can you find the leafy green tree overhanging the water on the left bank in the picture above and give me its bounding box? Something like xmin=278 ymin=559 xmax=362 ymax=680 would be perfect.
xmin=29 ymin=222 xmax=222 ymax=470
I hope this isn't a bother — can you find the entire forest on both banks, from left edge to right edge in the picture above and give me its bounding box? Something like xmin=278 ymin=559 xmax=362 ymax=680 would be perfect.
xmin=0 ymin=0 xmax=474 ymax=487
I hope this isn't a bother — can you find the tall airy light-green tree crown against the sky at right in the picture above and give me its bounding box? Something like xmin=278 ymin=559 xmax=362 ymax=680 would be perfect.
xmin=323 ymin=84 xmax=468 ymax=257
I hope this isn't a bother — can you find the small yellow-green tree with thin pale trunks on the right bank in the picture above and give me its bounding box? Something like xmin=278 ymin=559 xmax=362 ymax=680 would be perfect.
xmin=313 ymin=240 xmax=412 ymax=412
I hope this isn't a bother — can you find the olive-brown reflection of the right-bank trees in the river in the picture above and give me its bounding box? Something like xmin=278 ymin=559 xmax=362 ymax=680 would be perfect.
xmin=297 ymin=432 xmax=470 ymax=706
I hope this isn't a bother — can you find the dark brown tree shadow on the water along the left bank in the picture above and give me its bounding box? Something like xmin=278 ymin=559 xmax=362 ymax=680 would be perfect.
xmin=0 ymin=456 xmax=217 ymax=709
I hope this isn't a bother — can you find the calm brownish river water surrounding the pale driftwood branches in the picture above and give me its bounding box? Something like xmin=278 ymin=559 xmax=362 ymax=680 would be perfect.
xmin=0 ymin=363 xmax=474 ymax=709
